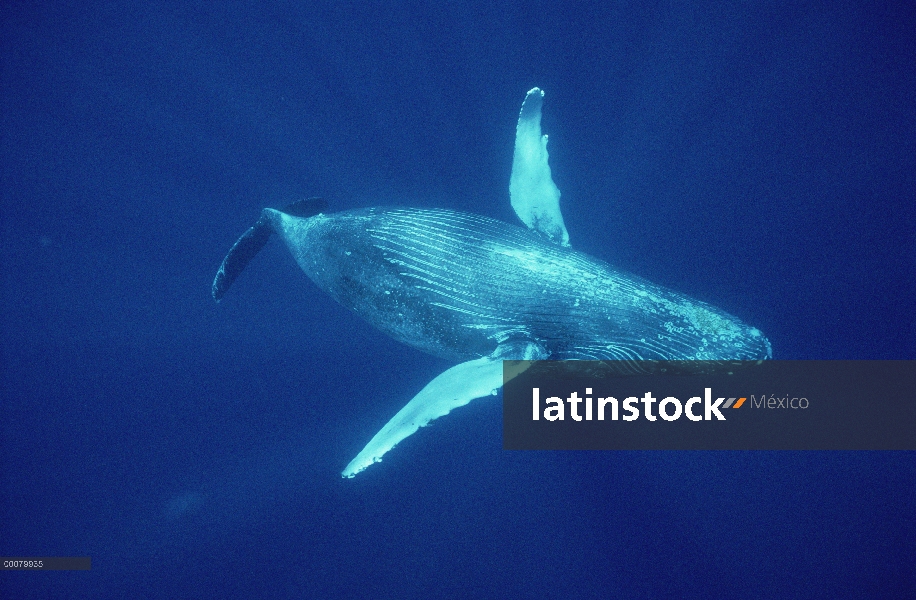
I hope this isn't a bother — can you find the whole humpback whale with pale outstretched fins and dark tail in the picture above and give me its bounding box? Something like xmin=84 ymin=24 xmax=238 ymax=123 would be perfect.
xmin=212 ymin=88 xmax=772 ymax=477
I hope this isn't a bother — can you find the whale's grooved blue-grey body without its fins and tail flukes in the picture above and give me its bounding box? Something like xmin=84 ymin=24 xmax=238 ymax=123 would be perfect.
xmin=265 ymin=208 xmax=769 ymax=361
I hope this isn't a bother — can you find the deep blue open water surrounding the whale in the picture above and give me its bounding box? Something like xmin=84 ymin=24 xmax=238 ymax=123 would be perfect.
xmin=0 ymin=0 xmax=916 ymax=599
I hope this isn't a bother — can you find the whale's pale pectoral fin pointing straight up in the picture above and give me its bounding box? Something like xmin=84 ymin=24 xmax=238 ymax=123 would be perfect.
xmin=509 ymin=88 xmax=569 ymax=246
